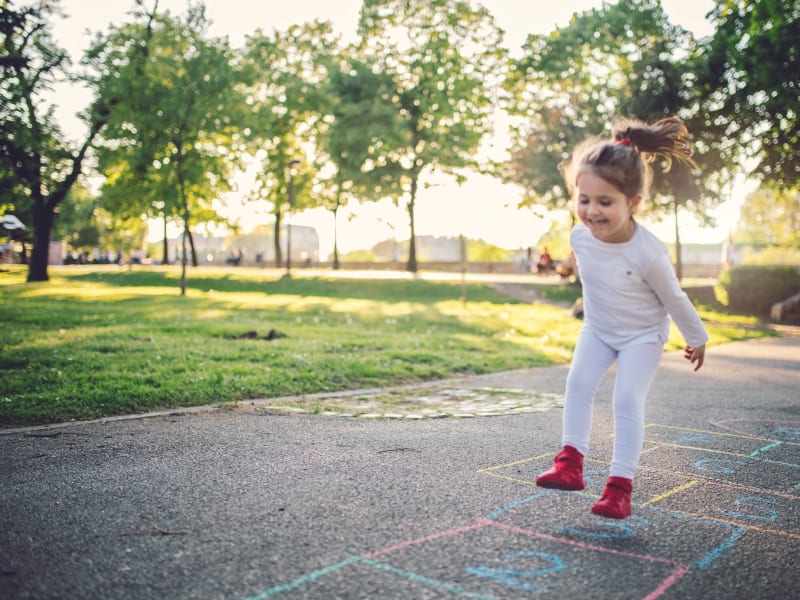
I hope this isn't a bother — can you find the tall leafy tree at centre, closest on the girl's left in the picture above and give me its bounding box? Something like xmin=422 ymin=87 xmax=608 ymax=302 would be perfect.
xmin=359 ymin=0 xmax=505 ymax=272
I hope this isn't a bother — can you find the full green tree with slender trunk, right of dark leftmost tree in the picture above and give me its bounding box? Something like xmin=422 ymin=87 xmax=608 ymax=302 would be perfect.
xmin=89 ymin=3 xmax=245 ymax=295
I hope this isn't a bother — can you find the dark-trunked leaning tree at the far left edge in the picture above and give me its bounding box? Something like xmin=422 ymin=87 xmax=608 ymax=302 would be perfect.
xmin=0 ymin=0 xmax=117 ymax=281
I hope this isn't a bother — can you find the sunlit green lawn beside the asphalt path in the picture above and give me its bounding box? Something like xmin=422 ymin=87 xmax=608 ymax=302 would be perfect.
xmin=0 ymin=266 xmax=769 ymax=426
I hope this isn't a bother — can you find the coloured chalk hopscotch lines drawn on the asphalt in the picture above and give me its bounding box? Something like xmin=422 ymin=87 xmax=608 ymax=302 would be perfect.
xmin=246 ymin=424 xmax=800 ymax=600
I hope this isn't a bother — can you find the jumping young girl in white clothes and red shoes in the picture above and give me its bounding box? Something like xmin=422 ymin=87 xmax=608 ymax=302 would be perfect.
xmin=536 ymin=118 xmax=708 ymax=519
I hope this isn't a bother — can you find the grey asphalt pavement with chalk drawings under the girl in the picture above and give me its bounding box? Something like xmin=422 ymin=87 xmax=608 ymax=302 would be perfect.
xmin=0 ymin=337 xmax=800 ymax=600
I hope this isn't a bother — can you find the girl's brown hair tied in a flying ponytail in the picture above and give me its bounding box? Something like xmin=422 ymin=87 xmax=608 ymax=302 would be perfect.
xmin=561 ymin=117 xmax=695 ymax=198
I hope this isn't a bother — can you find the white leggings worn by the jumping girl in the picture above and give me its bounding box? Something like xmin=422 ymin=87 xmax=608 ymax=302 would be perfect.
xmin=562 ymin=328 xmax=664 ymax=479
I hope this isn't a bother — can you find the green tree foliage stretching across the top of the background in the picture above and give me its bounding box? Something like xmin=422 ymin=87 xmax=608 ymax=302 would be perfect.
xmin=7 ymin=0 xmax=800 ymax=281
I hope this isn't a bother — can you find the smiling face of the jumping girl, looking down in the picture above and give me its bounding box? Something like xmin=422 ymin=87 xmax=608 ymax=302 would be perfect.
xmin=575 ymin=169 xmax=642 ymax=244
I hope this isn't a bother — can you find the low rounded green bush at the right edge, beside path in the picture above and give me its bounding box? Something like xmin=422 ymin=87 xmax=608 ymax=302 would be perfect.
xmin=714 ymin=265 xmax=800 ymax=317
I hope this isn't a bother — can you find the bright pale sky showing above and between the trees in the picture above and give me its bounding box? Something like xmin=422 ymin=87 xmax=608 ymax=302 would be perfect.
xmin=39 ymin=0 xmax=745 ymax=257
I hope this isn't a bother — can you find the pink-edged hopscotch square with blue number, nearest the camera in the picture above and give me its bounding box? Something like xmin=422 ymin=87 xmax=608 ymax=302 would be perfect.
xmin=364 ymin=520 xmax=688 ymax=599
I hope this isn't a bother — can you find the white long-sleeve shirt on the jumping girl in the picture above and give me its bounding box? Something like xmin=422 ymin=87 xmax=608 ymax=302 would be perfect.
xmin=570 ymin=223 xmax=708 ymax=350
